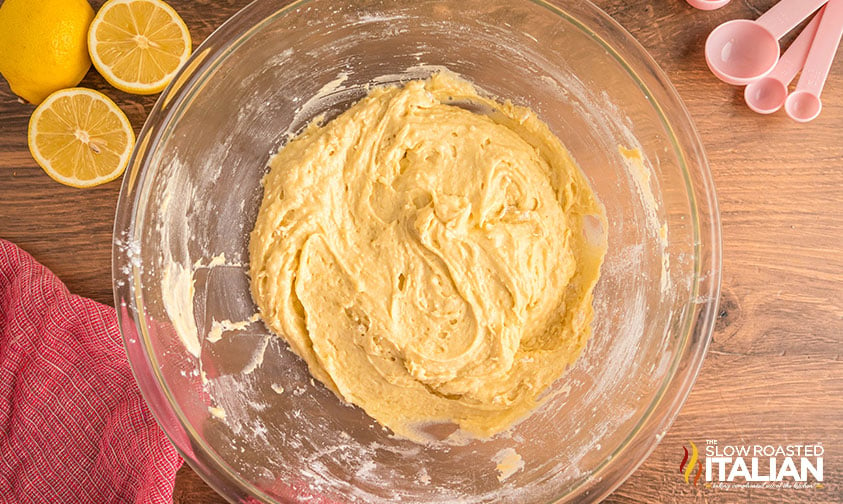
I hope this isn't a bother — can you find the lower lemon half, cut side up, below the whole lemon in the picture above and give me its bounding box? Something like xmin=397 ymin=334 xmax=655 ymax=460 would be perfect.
xmin=28 ymin=88 xmax=135 ymax=187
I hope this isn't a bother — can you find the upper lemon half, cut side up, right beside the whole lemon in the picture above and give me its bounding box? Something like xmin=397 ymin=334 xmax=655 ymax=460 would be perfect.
xmin=88 ymin=0 xmax=191 ymax=94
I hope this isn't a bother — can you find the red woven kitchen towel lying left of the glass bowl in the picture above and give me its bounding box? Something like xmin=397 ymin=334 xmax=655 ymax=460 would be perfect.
xmin=0 ymin=239 xmax=182 ymax=504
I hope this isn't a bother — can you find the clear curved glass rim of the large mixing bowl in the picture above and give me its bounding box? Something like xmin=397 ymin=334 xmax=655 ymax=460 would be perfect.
xmin=112 ymin=0 xmax=722 ymax=502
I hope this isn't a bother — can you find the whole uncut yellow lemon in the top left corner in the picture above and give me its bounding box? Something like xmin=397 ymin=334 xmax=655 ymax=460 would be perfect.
xmin=0 ymin=0 xmax=94 ymax=105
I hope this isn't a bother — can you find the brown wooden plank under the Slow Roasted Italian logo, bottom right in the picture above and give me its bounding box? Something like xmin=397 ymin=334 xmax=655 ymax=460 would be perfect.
xmin=607 ymin=350 xmax=843 ymax=503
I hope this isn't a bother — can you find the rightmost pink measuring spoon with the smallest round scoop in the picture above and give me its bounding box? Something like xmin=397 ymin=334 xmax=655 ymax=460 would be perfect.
xmin=784 ymin=0 xmax=843 ymax=122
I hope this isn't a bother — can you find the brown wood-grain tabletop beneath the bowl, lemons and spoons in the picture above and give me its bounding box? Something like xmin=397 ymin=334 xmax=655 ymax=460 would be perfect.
xmin=0 ymin=0 xmax=843 ymax=503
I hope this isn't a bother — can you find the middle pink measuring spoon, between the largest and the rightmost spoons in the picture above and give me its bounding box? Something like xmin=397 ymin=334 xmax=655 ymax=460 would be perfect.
xmin=743 ymin=7 xmax=825 ymax=114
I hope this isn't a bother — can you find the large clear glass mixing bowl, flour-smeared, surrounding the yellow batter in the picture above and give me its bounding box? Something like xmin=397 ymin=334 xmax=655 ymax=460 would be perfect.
xmin=114 ymin=0 xmax=720 ymax=504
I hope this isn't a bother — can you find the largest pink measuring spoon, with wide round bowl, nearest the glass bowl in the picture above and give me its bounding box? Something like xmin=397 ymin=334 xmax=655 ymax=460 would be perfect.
xmin=705 ymin=0 xmax=828 ymax=86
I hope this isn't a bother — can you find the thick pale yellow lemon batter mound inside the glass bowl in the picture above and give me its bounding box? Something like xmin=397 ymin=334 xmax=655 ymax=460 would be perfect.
xmin=249 ymin=73 xmax=605 ymax=438
